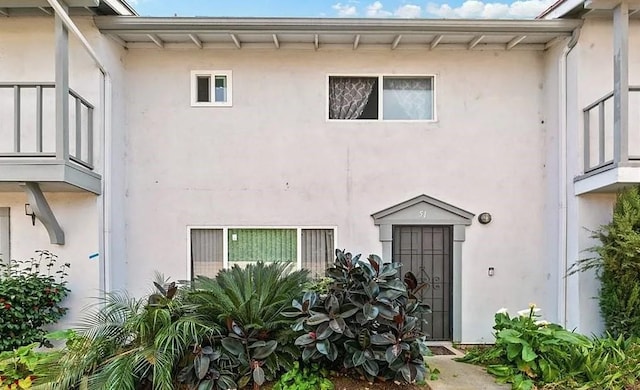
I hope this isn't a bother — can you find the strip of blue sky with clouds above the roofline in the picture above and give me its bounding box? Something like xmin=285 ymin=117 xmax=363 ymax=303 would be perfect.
xmin=127 ymin=0 xmax=554 ymax=19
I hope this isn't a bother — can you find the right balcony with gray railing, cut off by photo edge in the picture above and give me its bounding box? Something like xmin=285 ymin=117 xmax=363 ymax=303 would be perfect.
xmin=574 ymin=86 xmax=640 ymax=195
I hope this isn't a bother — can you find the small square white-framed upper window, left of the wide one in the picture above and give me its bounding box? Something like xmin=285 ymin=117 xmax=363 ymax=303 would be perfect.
xmin=191 ymin=70 xmax=231 ymax=107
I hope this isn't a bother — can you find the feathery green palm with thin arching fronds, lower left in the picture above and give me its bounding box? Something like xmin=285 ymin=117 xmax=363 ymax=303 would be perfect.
xmin=49 ymin=281 xmax=221 ymax=390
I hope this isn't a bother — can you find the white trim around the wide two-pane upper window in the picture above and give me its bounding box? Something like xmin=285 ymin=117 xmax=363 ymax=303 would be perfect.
xmin=324 ymin=73 xmax=438 ymax=123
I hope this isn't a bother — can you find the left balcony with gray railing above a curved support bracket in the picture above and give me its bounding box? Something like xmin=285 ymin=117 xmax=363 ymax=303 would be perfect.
xmin=0 ymin=83 xmax=101 ymax=194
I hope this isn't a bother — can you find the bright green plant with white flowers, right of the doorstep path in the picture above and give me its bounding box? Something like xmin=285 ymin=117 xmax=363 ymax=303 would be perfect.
xmin=457 ymin=304 xmax=591 ymax=390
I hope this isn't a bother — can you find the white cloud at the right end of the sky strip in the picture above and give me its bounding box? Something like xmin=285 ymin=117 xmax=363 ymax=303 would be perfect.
xmin=427 ymin=0 xmax=554 ymax=19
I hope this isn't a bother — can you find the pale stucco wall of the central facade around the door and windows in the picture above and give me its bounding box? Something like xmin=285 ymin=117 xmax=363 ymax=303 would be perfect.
xmin=126 ymin=49 xmax=557 ymax=342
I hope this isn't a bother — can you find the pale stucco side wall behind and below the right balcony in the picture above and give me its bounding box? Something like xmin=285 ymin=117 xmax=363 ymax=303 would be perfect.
xmin=567 ymin=18 xmax=640 ymax=334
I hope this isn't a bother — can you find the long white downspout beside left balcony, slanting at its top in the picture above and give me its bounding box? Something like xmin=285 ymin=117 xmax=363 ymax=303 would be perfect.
xmin=47 ymin=0 xmax=111 ymax=293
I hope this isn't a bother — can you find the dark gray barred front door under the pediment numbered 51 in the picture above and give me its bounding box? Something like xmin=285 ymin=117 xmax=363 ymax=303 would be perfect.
xmin=392 ymin=225 xmax=453 ymax=340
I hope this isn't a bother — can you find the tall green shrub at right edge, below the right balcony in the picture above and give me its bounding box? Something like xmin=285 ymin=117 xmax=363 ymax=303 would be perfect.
xmin=574 ymin=186 xmax=640 ymax=337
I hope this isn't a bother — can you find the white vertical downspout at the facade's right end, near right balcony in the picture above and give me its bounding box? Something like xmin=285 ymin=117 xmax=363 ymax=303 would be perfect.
xmin=558 ymin=27 xmax=580 ymax=328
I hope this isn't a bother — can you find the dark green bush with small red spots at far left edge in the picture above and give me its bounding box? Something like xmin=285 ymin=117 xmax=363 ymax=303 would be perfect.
xmin=0 ymin=251 xmax=69 ymax=351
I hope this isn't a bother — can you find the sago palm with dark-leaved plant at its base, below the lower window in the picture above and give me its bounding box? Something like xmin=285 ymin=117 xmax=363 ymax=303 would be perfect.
xmin=181 ymin=262 xmax=308 ymax=388
